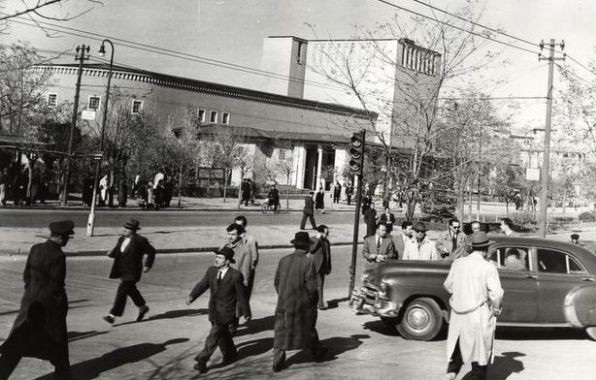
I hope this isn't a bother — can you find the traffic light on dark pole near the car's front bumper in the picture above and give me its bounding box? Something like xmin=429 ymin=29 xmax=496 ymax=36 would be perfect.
xmin=348 ymin=130 xmax=366 ymax=298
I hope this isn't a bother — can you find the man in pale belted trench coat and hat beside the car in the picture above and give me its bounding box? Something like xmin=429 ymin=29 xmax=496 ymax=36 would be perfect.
xmin=443 ymin=231 xmax=503 ymax=380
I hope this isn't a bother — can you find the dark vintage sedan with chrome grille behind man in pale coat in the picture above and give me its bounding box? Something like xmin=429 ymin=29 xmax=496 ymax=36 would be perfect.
xmin=351 ymin=236 xmax=596 ymax=340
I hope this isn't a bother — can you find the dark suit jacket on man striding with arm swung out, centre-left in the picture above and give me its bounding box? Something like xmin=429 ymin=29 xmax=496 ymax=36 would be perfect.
xmin=190 ymin=266 xmax=251 ymax=325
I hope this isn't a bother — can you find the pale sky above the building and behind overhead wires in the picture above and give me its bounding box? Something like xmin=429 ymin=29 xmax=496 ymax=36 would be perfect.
xmin=0 ymin=0 xmax=596 ymax=132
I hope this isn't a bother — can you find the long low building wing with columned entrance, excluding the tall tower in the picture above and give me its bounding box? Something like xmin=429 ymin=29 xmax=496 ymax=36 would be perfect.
xmin=35 ymin=64 xmax=377 ymax=189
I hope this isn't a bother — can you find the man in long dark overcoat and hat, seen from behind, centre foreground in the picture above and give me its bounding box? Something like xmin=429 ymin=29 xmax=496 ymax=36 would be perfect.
xmin=273 ymin=232 xmax=326 ymax=372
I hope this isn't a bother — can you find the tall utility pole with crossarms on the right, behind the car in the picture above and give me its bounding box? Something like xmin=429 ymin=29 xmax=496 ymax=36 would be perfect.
xmin=538 ymin=38 xmax=565 ymax=238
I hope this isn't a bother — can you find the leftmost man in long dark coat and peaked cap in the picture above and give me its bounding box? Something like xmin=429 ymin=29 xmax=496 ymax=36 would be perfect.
xmin=0 ymin=220 xmax=74 ymax=380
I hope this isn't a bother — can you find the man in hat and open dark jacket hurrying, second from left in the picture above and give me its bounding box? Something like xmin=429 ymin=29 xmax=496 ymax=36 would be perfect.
xmin=103 ymin=219 xmax=155 ymax=324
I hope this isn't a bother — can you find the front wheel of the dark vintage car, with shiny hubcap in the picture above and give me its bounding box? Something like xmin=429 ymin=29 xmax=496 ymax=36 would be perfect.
xmin=395 ymin=297 xmax=443 ymax=340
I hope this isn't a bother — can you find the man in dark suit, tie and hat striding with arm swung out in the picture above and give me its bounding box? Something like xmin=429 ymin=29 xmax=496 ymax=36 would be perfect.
xmin=186 ymin=247 xmax=251 ymax=373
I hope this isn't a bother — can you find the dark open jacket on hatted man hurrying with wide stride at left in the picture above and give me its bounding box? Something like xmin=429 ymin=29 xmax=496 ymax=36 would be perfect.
xmin=108 ymin=235 xmax=155 ymax=282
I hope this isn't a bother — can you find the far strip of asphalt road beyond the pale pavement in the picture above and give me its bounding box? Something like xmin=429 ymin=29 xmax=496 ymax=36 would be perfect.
xmin=0 ymin=209 xmax=354 ymax=227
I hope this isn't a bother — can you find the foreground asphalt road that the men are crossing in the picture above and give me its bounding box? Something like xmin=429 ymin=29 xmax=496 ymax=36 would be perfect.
xmin=0 ymin=247 xmax=596 ymax=380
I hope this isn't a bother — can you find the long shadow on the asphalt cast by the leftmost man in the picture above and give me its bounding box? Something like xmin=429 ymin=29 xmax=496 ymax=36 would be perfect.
xmin=36 ymin=338 xmax=189 ymax=380
